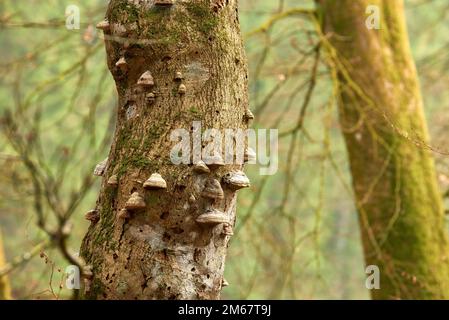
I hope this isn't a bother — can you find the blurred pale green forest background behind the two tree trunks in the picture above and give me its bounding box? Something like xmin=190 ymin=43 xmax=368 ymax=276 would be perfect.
xmin=0 ymin=0 xmax=449 ymax=299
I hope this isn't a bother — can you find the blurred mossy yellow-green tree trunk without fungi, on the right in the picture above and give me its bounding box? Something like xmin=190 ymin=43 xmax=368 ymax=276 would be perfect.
xmin=318 ymin=0 xmax=449 ymax=299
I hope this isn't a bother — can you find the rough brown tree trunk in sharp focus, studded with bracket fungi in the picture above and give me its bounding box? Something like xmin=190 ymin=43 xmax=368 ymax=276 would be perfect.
xmin=81 ymin=0 xmax=248 ymax=299
